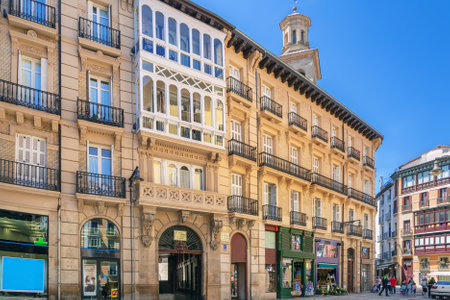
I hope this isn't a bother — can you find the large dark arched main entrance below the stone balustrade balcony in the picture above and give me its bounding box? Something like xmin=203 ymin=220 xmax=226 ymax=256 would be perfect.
xmin=158 ymin=225 xmax=203 ymax=300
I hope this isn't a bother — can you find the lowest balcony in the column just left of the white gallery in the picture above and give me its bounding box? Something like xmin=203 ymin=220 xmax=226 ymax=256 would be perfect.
xmin=77 ymin=171 xmax=126 ymax=198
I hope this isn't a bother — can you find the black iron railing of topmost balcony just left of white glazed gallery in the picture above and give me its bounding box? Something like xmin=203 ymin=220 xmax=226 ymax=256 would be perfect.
xmin=78 ymin=17 xmax=120 ymax=49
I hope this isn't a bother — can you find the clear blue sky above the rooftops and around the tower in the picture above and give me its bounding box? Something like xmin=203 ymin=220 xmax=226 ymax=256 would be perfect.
xmin=194 ymin=0 xmax=450 ymax=188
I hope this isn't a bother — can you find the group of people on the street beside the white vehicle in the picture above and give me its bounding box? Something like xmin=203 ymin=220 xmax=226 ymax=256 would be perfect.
xmin=375 ymin=275 xmax=436 ymax=297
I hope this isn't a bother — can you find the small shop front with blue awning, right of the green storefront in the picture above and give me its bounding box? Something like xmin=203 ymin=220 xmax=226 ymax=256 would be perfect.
xmin=316 ymin=239 xmax=340 ymax=291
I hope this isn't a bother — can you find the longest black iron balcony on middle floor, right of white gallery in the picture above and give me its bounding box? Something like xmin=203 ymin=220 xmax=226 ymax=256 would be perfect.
xmin=258 ymin=152 xmax=311 ymax=181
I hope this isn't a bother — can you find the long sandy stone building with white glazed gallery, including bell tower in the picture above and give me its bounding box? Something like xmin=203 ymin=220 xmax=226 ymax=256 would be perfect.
xmin=0 ymin=0 xmax=383 ymax=299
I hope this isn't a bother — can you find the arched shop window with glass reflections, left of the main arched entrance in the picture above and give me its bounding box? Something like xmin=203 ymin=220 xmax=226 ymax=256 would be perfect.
xmin=81 ymin=219 xmax=121 ymax=300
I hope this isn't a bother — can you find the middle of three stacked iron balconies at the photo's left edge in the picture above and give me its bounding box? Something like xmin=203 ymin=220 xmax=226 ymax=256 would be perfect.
xmin=0 ymin=79 xmax=61 ymax=115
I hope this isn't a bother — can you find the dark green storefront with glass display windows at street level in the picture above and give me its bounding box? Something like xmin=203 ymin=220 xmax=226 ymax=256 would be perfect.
xmin=277 ymin=227 xmax=316 ymax=298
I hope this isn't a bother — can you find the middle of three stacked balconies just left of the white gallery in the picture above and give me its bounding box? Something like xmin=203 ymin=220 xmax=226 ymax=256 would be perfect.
xmin=77 ymin=99 xmax=123 ymax=127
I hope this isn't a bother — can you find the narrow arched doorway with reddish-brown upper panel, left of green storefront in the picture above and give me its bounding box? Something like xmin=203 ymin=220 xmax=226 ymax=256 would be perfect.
xmin=231 ymin=233 xmax=247 ymax=300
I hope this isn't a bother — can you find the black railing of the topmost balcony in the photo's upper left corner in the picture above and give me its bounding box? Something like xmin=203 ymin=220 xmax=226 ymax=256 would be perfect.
xmin=8 ymin=0 xmax=56 ymax=28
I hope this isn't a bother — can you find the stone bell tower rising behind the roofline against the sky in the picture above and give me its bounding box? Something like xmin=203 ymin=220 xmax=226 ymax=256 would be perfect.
xmin=280 ymin=1 xmax=322 ymax=83
